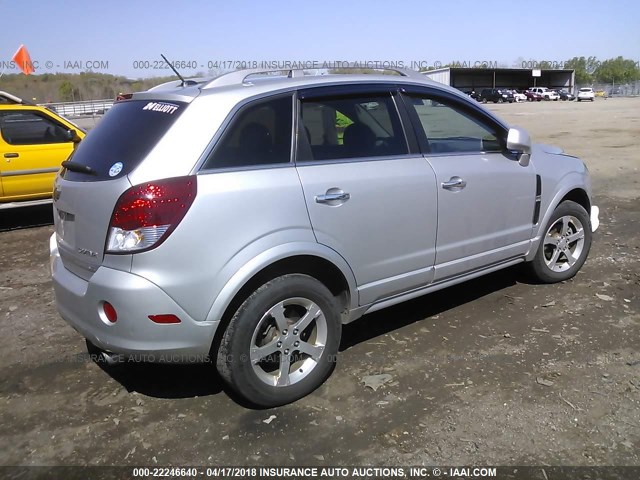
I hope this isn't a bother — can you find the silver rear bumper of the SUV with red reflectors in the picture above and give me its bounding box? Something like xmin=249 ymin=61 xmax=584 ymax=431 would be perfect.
xmin=49 ymin=234 xmax=218 ymax=363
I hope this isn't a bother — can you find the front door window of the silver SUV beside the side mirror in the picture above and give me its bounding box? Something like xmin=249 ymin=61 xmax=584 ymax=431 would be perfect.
xmin=408 ymin=95 xmax=502 ymax=153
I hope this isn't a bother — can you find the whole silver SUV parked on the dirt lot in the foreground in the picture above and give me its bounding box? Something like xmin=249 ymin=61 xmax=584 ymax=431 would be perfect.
xmin=50 ymin=67 xmax=598 ymax=406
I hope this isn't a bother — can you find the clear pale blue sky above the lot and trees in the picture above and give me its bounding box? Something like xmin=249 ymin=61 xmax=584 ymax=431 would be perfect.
xmin=0 ymin=0 xmax=640 ymax=81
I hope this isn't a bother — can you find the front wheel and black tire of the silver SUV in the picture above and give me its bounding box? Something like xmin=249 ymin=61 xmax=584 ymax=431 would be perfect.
xmin=528 ymin=200 xmax=592 ymax=283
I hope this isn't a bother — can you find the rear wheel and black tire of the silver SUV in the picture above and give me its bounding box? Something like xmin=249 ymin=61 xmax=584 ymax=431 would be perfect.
xmin=216 ymin=274 xmax=342 ymax=407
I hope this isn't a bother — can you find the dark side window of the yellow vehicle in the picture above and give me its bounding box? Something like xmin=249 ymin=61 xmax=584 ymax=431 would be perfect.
xmin=0 ymin=111 xmax=69 ymax=145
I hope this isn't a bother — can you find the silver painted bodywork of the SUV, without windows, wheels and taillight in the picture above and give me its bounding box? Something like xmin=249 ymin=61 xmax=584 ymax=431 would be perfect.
xmin=50 ymin=69 xmax=591 ymax=360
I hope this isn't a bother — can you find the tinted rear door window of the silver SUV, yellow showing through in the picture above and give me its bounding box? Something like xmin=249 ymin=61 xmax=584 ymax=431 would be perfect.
xmin=297 ymin=94 xmax=408 ymax=161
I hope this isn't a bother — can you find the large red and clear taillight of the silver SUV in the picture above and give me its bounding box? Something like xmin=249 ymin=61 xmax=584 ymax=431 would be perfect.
xmin=106 ymin=176 xmax=197 ymax=253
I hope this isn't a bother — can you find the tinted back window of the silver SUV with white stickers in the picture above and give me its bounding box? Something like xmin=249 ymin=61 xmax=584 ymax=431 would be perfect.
xmin=63 ymin=100 xmax=187 ymax=182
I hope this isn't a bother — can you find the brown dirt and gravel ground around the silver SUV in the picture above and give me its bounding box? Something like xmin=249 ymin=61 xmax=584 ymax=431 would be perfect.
xmin=0 ymin=99 xmax=640 ymax=466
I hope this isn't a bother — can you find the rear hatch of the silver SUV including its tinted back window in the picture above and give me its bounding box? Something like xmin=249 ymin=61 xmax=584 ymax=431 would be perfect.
xmin=53 ymin=99 xmax=187 ymax=280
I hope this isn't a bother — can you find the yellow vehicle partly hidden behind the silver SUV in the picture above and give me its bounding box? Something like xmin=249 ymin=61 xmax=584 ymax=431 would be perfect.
xmin=0 ymin=92 xmax=85 ymax=209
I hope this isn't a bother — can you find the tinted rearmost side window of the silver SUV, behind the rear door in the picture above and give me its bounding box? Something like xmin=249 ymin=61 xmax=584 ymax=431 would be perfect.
xmin=203 ymin=95 xmax=293 ymax=169
